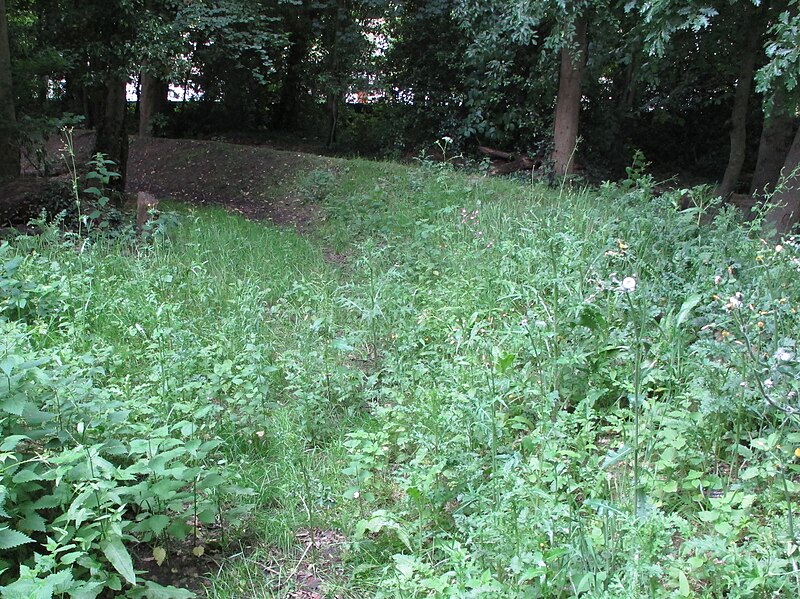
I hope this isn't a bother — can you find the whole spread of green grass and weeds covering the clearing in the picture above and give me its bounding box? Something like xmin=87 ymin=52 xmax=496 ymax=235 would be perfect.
xmin=0 ymin=161 xmax=800 ymax=597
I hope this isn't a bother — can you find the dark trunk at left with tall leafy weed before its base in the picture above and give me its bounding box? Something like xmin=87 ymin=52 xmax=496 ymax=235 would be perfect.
xmin=94 ymin=77 xmax=128 ymax=191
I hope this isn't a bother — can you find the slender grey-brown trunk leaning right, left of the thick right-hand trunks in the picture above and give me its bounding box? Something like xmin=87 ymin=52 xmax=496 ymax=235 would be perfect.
xmin=716 ymin=10 xmax=761 ymax=199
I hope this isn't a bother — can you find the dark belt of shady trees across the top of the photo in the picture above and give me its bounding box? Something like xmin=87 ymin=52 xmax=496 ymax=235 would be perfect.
xmin=0 ymin=0 xmax=800 ymax=230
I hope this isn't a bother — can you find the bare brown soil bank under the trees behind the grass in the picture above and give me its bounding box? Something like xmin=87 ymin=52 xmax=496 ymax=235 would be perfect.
xmin=0 ymin=131 xmax=336 ymax=232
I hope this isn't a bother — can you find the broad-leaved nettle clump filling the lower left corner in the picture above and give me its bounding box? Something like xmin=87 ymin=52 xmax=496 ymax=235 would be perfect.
xmin=0 ymin=258 xmax=250 ymax=598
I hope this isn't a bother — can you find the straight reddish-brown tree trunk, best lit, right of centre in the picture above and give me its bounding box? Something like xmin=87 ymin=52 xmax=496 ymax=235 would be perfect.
xmin=552 ymin=15 xmax=587 ymax=176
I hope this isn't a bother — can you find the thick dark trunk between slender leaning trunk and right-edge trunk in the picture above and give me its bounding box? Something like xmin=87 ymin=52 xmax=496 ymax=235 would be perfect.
xmin=750 ymin=91 xmax=794 ymax=196
